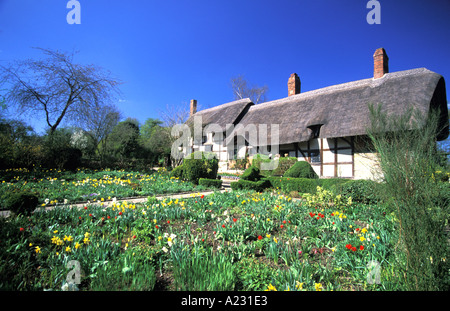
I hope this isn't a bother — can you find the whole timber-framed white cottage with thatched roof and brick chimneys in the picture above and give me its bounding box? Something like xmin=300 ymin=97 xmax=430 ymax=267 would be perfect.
xmin=187 ymin=48 xmax=449 ymax=179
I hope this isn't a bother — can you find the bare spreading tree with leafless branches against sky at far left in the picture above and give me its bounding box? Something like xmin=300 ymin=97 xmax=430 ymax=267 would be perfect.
xmin=0 ymin=48 xmax=120 ymax=134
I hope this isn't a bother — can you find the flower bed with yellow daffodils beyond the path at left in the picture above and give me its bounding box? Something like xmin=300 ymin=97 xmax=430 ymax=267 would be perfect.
xmin=0 ymin=169 xmax=204 ymax=210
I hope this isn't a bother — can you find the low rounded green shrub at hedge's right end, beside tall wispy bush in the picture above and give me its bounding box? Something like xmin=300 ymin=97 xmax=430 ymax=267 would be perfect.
xmin=339 ymin=179 xmax=380 ymax=204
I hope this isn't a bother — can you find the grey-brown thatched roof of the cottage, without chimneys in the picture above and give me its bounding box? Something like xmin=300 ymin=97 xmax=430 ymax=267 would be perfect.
xmin=188 ymin=68 xmax=448 ymax=145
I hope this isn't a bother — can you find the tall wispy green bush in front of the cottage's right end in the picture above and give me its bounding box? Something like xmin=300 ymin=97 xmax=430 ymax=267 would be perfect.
xmin=368 ymin=105 xmax=450 ymax=291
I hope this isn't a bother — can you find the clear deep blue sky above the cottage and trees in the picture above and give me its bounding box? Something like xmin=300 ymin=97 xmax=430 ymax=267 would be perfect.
xmin=0 ymin=0 xmax=450 ymax=137
